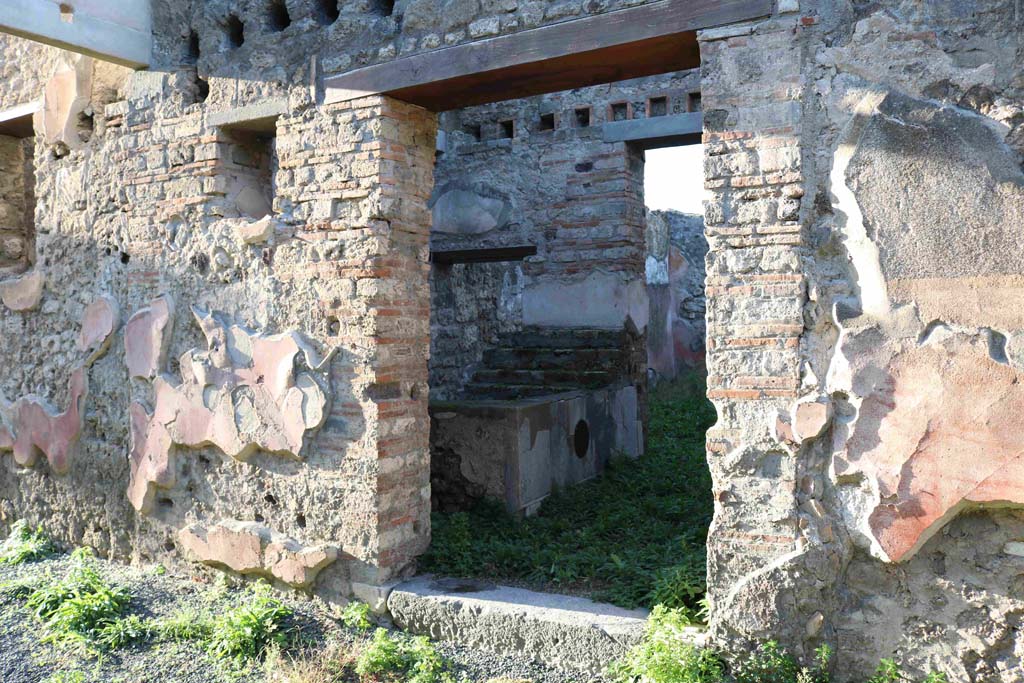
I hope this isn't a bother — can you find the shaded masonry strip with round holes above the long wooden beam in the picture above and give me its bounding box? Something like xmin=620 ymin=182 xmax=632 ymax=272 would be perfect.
xmin=153 ymin=0 xmax=667 ymax=87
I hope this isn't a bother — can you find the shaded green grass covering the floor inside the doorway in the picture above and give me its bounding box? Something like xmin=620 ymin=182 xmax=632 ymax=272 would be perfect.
xmin=423 ymin=376 xmax=715 ymax=620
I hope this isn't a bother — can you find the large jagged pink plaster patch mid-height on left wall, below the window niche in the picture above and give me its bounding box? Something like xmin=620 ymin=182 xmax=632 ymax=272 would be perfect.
xmin=126 ymin=309 xmax=327 ymax=513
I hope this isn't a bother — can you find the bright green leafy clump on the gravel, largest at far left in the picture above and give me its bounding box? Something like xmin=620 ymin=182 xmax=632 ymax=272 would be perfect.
xmin=26 ymin=548 xmax=131 ymax=644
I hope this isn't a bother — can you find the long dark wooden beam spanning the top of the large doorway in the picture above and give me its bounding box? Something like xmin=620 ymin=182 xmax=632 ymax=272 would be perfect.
xmin=325 ymin=0 xmax=772 ymax=112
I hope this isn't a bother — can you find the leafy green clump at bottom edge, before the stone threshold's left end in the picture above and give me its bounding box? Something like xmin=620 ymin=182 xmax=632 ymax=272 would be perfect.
xmin=355 ymin=629 xmax=454 ymax=683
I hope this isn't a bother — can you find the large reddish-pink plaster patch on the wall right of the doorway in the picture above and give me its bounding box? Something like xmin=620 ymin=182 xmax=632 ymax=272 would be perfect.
xmin=842 ymin=343 xmax=1024 ymax=562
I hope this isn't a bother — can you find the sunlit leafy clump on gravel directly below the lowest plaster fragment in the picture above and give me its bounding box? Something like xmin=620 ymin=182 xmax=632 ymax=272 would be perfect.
xmin=207 ymin=582 xmax=292 ymax=665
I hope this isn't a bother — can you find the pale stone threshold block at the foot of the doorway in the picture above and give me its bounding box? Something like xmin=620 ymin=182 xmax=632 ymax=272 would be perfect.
xmin=387 ymin=577 xmax=667 ymax=675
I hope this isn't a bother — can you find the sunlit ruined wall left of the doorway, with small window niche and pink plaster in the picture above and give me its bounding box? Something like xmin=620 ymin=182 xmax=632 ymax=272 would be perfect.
xmin=0 ymin=26 xmax=436 ymax=598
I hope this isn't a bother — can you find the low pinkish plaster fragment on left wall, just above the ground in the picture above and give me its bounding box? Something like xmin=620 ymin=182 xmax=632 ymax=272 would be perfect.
xmin=178 ymin=520 xmax=338 ymax=588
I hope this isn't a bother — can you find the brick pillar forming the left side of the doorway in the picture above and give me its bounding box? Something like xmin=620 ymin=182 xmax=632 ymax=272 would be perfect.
xmin=275 ymin=96 xmax=437 ymax=587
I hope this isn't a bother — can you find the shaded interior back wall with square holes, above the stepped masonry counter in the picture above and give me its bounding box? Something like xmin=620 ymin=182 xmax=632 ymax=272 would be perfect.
xmin=431 ymin=72 xmax=699 ymax=398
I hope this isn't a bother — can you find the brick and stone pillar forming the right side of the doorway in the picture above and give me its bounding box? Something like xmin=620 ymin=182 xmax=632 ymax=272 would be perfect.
xmin=701 ymin=17 xmax=840 ymax=654
